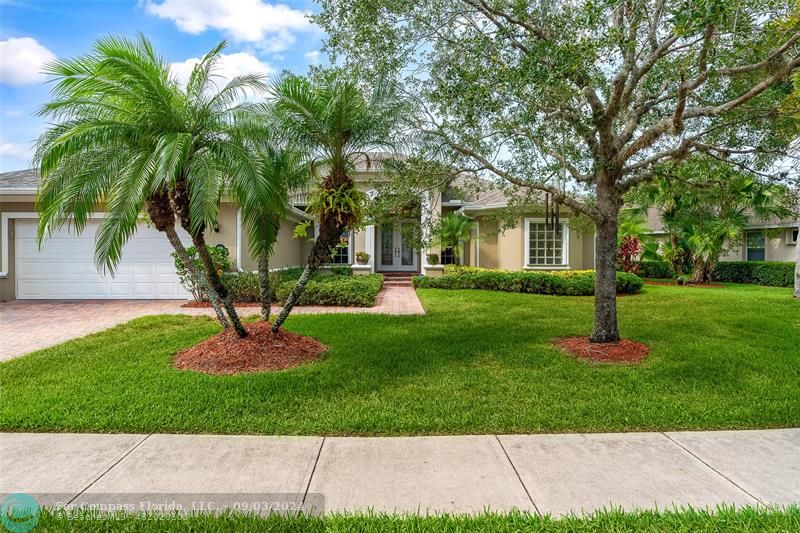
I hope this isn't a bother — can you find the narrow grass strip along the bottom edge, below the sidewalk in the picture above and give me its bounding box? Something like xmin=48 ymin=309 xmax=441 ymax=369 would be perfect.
xmin=34 ymin=507 xmax=800 ymax=533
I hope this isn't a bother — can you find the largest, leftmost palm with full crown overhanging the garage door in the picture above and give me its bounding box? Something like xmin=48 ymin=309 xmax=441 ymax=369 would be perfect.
xmin=35 ymin=35 xmax=269 ymax=337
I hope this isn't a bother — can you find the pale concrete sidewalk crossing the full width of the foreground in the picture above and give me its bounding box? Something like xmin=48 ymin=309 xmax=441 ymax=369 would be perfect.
xmin=0 ymin=429 xmax=800 ymax=515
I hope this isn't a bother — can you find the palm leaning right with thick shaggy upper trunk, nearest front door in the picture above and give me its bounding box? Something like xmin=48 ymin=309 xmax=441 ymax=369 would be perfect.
xmin=272 ymin=70 xmax=407 ymax=331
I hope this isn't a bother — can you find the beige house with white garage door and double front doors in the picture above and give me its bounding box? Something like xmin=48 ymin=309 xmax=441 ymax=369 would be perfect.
xmin=0 ymin=160 xmax=594 ymax=300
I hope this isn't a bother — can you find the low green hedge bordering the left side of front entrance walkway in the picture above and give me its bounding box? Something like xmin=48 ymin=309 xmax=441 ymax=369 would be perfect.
xmin=276 ymin=274 xmax=383 ymax=307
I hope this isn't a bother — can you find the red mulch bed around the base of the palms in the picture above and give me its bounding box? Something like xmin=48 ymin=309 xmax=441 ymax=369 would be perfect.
xmin=173 ymin=321 xmax=326 ymax=375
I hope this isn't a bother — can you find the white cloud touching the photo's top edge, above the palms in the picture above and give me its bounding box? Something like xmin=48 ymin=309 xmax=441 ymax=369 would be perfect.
xmin=145 ymin=0 xmax=314 ymax=42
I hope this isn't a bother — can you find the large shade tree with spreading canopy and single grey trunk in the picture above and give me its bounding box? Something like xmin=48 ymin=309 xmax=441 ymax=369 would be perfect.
xmin=316 ymin=0 xmax=800 ymax=342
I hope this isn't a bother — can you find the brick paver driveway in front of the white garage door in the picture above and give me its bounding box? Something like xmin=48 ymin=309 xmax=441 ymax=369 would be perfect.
xmin=0 ymin=300 xmax=185 ymax=361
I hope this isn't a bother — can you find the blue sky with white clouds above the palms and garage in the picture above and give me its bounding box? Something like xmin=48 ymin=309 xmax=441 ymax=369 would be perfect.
xmin=0 ymin=0 xmax=325 ymax=172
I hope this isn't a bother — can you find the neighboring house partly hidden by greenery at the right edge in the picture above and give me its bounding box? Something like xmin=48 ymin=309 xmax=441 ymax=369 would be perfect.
xmin=645 ymin=208 xmax=798 ymax=262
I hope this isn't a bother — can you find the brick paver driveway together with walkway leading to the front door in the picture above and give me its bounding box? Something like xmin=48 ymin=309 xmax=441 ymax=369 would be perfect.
xmin=0 ymin=287 xmax=425 ymax=361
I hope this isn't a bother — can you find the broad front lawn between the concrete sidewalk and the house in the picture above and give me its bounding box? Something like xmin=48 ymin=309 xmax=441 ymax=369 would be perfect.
xmin=0 ymin=285 xmax=800 ymax=435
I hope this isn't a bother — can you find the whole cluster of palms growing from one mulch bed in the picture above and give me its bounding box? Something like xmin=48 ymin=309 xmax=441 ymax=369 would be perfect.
xmin=34 ymin=35 xmax=410 ymax=337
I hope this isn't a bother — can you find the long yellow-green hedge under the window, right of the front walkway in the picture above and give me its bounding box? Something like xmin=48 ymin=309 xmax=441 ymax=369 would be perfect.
xmin=414 ymin=266 xmax=643 ymax=296
